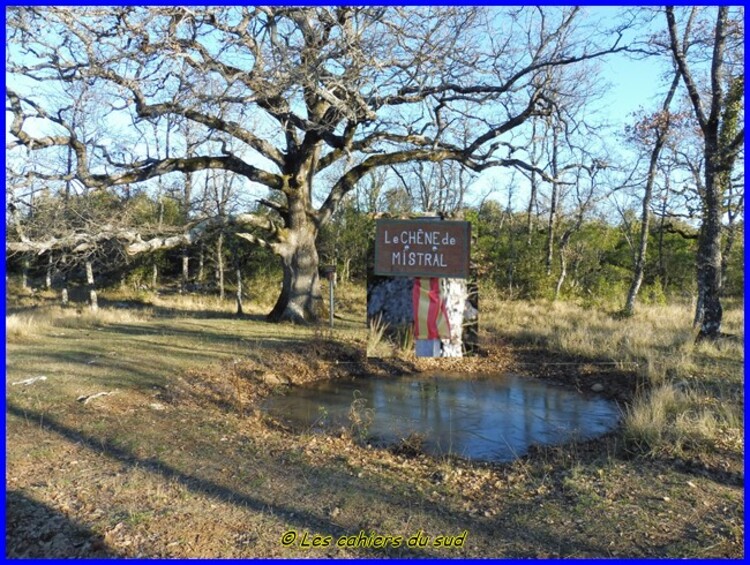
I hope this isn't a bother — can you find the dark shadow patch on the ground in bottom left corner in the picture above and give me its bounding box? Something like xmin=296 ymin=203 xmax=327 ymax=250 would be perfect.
xmin=5 ymin=490 xmax=118 ymax=559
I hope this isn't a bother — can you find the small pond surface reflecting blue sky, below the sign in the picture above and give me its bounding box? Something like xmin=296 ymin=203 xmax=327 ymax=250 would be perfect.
xmin=265 ymin=374 xmax=619 ymax=461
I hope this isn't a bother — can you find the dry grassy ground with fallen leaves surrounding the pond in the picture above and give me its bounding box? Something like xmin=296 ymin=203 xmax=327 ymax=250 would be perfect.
xmin=6 ymin=286 xmax=744 ymax=558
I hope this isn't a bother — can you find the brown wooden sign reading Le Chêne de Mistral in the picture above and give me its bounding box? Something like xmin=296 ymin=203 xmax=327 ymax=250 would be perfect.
xmin=375 ymin=219 xmax=471 ymax=278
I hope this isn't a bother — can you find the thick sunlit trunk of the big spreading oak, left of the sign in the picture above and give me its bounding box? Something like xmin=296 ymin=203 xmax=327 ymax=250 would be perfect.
xmin=268 ymin=223 xmax=323 ymax=323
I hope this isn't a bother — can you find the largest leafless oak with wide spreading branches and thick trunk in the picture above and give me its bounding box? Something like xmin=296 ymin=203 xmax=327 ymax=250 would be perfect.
xmin=6 ymin=6 xmax=636 ymax=321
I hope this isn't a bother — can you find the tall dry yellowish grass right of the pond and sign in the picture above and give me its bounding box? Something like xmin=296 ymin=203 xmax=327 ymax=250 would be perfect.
xmin=482 ymin=288 xmax=744 ymax=456
